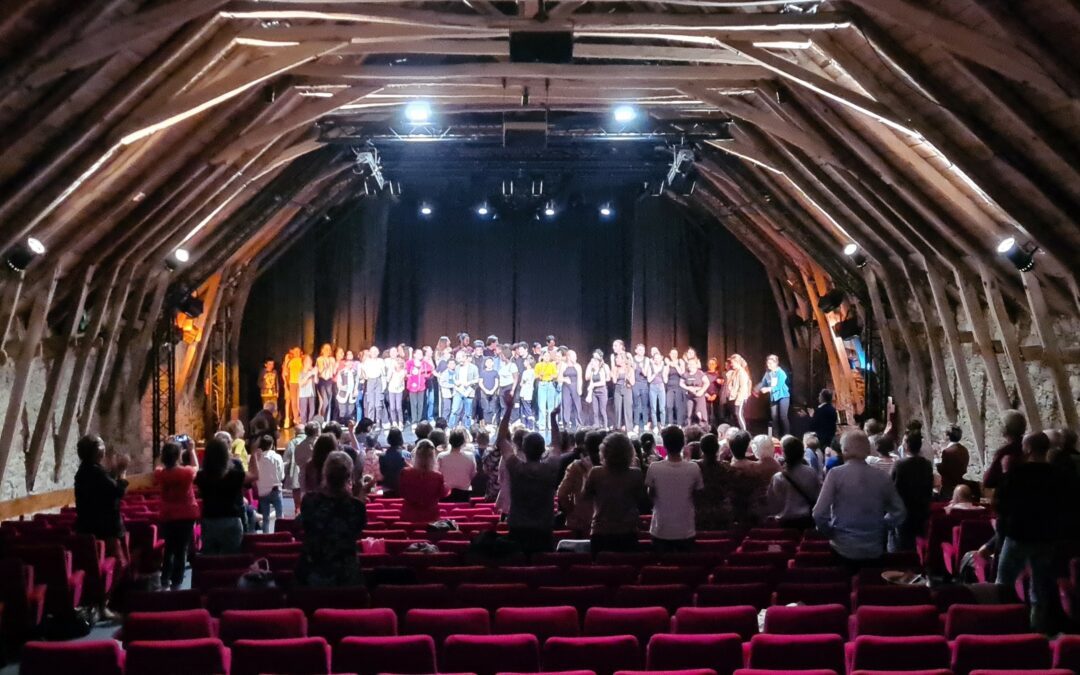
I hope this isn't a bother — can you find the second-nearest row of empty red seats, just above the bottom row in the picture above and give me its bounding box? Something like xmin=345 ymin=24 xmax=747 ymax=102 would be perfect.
xmin=117 ymin=605 xmax=1036 ymax=645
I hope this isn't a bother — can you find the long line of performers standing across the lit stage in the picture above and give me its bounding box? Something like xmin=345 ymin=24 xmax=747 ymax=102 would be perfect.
xmin=259 ymin=333 xmax=789 ymax=434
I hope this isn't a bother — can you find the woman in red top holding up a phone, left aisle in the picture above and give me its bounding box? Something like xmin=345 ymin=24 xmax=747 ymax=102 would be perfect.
xmin=153 ymin=443 xmax=199 ymax=591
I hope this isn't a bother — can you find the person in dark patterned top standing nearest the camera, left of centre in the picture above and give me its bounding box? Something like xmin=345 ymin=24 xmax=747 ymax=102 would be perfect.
xmin=296 ymin=449 xmax=367 ymax=586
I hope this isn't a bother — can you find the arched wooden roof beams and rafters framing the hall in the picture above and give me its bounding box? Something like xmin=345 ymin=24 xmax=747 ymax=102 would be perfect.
xmin=0 ymin=0 xmax=1080 ymax=494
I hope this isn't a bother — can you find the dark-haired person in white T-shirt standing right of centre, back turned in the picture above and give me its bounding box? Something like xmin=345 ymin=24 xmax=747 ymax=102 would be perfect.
xmin=645 ymin=424 xmax=705 ymax=553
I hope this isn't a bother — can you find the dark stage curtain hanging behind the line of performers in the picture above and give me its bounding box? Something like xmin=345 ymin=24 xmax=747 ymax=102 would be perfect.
xmin=240 ymin=191 xmax=787 ymax=416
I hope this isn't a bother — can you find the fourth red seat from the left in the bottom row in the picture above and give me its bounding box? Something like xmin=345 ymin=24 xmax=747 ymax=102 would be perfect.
xmin=334 ymin=635 xmax=436 ymax=675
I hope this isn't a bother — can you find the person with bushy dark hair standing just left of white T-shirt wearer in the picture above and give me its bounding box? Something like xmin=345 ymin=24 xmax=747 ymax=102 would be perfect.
xmin=584 ymin=433 xmax=648 ymax=554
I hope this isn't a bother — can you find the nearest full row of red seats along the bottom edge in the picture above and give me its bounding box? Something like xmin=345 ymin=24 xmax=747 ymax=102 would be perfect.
xmin=22 ymin=633 xmax=1080 ymax=675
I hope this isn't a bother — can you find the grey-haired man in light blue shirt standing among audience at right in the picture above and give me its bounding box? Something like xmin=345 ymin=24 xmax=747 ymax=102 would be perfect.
xmin=813 ymin=430 xmax=906 ymax=570
